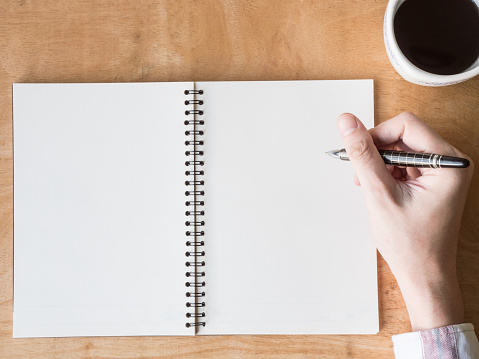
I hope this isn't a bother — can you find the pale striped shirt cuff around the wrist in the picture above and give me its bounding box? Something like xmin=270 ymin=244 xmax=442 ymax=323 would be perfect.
xmin=392 ymin=323 xmax=479 ymax=359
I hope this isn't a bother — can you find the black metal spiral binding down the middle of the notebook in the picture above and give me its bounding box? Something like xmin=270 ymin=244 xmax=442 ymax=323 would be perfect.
xmin=184 ymin=90 xmax=206 ymax=328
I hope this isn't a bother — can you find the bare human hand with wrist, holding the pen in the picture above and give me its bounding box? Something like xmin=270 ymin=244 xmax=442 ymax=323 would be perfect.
xmin=338 ymin=112 xmax=474 ymax=330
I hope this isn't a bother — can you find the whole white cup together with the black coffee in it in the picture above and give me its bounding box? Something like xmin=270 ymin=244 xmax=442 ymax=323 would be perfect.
xmin=384 ymin=0 xmax=479 ymax=86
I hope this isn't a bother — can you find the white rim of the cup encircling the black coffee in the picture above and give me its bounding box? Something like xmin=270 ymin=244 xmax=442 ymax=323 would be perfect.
xmin=384 ymin=0 xmax=479 ymax=82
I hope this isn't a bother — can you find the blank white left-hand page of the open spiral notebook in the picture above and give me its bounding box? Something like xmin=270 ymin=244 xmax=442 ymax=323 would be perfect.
xmin=13 ymin=83 xmax=194 ymax=337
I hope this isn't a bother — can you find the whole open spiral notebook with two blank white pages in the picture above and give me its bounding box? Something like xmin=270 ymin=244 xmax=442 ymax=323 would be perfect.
xmin=13 ymin=80 xmax=378 ymax=337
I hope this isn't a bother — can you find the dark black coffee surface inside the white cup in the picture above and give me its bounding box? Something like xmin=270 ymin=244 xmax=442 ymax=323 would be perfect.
xmin=394 ymin=0 xmax=479 ymax=75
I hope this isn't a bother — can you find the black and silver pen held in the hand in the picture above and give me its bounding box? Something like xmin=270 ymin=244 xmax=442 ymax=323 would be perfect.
xmin=326 ymin=148 xmax=469 ymax=168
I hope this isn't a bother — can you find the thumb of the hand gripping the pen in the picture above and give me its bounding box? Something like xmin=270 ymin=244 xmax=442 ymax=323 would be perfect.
xmin=338 ymin=113 xmax=395 ymax=193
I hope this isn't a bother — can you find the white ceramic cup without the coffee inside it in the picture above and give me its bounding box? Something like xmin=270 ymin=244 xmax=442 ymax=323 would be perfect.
xmin=384 ymin=0 xmax=479 ymax=86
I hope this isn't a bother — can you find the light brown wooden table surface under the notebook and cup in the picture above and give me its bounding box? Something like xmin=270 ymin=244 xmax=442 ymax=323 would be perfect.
xmin=0 ymin=0 xmax=479 ymax=359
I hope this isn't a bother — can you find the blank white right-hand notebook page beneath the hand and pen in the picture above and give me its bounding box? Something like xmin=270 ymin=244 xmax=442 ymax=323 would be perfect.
xmin=197 ymin=80 xmax=378 ymax=334
